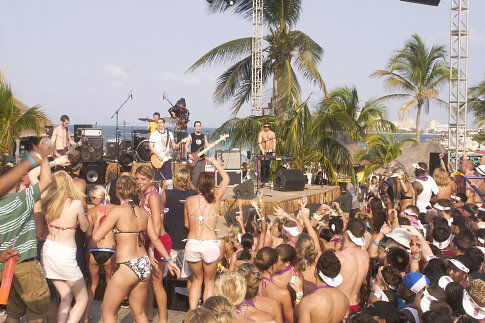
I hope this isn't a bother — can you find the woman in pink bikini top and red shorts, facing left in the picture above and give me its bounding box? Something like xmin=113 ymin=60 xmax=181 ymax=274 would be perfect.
xmin=135 ymin=164 xmax=172 ymax=322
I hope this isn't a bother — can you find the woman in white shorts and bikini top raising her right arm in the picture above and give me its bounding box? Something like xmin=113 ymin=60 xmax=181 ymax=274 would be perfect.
xmin=185 ymin=157 xmax=229 ymax=309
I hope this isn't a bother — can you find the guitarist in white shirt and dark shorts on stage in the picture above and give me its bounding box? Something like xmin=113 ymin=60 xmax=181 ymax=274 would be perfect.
xmin=148 ymin=118 xmax=179 ymax=189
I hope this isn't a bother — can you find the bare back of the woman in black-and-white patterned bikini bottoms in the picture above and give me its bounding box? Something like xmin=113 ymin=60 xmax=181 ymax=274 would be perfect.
xmin=110 ymin=204 xmax=149 ymax=263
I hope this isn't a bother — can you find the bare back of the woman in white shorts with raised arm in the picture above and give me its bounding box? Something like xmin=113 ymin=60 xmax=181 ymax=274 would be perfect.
xmin=185 ymin=194 xmax=219 ymax=240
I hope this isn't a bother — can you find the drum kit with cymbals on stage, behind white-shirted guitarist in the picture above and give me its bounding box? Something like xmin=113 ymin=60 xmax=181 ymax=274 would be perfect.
xmin=115 ymin=118 xmax=177 ymax=163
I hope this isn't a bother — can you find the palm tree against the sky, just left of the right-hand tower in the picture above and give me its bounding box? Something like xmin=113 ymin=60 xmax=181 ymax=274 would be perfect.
xmin=372 ymin=34 xmax=449 ymax=142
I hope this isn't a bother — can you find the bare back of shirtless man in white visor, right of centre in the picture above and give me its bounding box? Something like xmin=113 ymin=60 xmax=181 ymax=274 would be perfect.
xmin=336 ymin=247 xmax=369 ymax=305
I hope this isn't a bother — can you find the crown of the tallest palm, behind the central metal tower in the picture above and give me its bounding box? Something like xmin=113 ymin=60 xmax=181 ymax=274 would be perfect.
xmin=188 ymin=0 xmax=327 ymax=115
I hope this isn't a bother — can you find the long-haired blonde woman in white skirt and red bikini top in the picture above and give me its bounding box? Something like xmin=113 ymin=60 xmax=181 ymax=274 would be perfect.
xmin=41 ymin=171 xmax=92 ymax=322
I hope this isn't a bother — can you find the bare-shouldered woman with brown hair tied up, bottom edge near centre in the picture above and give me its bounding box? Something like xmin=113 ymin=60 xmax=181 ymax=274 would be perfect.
xmin=254 ymin=247 xmax=293 ymax=323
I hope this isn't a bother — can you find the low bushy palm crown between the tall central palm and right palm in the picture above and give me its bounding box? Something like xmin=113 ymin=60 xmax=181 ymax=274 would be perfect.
xmin=319 ymin=86 xmax=397 ymax=140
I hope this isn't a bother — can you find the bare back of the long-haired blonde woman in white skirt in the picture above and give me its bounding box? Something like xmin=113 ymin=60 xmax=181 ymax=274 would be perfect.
xmin=47 ymin=199 xmax=84 ymax=247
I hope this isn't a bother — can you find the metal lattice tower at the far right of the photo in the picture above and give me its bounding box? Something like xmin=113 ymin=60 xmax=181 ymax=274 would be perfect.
xmin=448 ymin=0 xmax=470 ymax=170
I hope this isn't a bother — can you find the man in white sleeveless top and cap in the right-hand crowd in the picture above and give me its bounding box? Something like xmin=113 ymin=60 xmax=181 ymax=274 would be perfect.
xmin=412 ymin=162 xmax=439 ymax=213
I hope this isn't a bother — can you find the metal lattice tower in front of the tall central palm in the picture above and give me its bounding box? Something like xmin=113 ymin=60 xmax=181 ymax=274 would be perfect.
xmin=251 ymin=0 xmax=263 ymax=116
